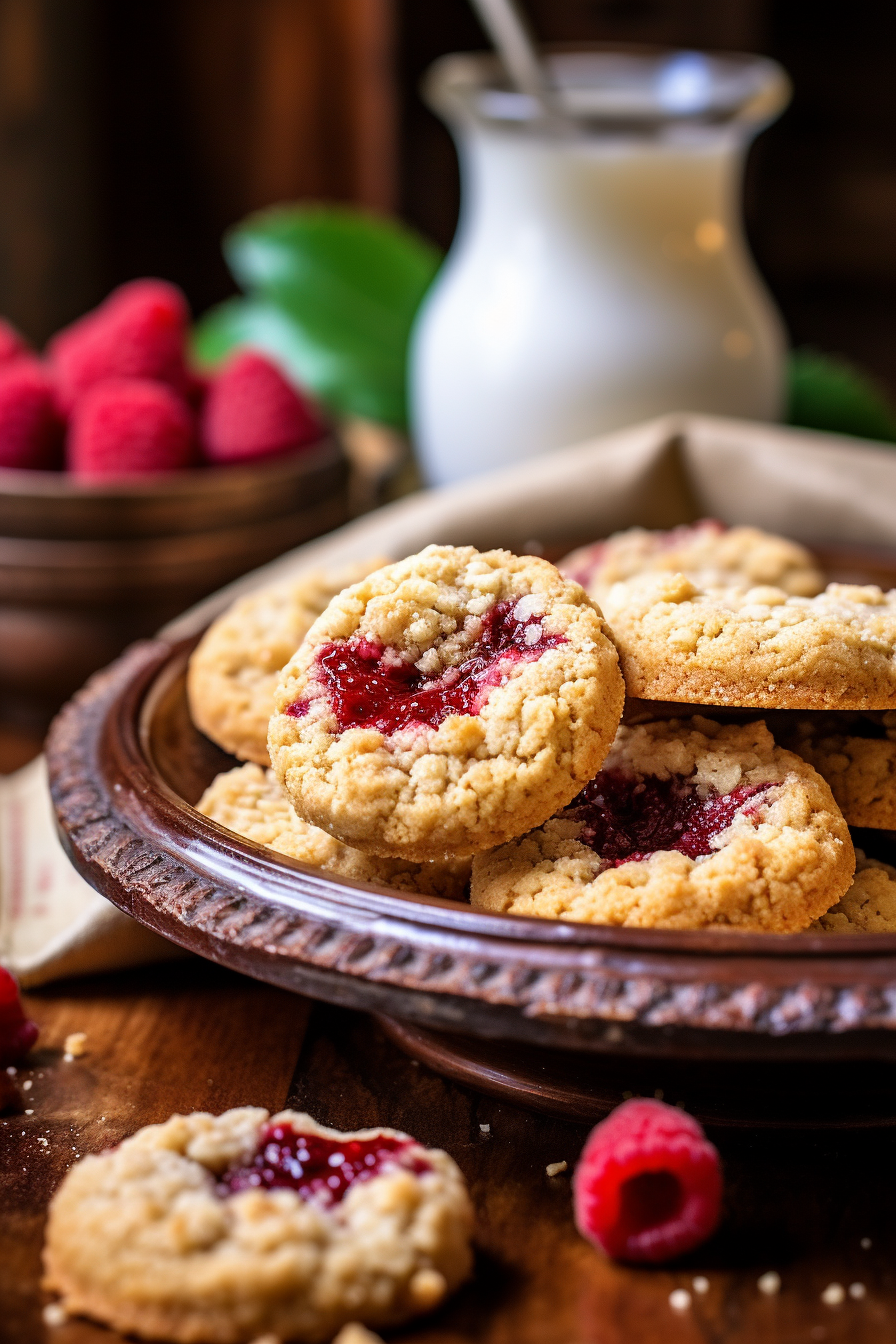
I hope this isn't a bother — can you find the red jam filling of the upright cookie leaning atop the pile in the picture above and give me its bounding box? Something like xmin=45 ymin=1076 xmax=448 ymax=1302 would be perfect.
xmin=286 ymin=601 xmax=566 ymax=735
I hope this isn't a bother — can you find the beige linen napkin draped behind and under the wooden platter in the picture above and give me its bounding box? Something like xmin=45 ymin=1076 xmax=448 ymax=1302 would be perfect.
xmin=10 ymin=403 xmax=896 ymax=984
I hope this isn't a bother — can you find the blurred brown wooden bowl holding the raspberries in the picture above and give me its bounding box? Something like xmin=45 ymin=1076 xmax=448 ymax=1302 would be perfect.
xmin=0 ymin=438 xmax=348 ymax=718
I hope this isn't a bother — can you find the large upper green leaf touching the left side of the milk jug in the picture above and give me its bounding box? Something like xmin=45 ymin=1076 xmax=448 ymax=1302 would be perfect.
xmin=217 ymin=206 xmax=441 ymax=425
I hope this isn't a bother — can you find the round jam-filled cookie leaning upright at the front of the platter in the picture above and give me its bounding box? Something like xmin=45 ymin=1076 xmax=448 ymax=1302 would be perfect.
xmin=267 ymin=546 xmax=623 ymax=860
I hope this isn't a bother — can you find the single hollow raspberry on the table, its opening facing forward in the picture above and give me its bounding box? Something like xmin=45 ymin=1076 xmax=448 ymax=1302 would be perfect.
xmin=572 ymin=1099 xmax=721 ymax=1262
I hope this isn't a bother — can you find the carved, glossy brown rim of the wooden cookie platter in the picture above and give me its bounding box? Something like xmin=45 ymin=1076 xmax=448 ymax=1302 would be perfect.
xmin=47 ymin=640 xmax=896 ymax=1054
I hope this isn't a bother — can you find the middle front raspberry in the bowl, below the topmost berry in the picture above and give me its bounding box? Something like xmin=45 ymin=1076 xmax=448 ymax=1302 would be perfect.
xmin=69 ymin=378 xmax=195 ymax=477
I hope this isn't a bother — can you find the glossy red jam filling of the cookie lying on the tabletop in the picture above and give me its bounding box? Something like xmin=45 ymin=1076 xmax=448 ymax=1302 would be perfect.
xmin=219 ymin=1124 xmax=433 ymax=1204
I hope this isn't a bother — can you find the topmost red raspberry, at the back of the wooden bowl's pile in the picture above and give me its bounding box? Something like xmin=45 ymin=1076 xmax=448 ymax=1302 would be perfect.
xmin=47 ymin=280 xmax=189 ymax=411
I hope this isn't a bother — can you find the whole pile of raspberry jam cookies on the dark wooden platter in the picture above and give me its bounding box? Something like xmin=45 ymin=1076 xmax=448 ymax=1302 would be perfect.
xmin=188 ymin=523 xmax=896 ymax=933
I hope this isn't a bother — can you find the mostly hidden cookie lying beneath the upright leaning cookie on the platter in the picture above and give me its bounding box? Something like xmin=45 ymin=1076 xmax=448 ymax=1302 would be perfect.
xmin=196 ymin=762 xmax=470 ymax=900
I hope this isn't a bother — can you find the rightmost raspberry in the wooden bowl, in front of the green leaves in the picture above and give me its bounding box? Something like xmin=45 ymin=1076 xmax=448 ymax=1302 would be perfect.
xmin=200 ymin=349 xmax=324 ymax=462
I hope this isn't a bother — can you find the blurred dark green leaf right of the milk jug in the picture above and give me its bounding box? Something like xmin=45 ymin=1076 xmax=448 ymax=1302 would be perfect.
xmin=787 ymin=349 xmax=896 ymax=444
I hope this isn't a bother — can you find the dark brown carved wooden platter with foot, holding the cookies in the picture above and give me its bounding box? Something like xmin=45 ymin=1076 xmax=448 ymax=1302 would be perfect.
xmin=41 ymin=542 xmax=896 ymax=1124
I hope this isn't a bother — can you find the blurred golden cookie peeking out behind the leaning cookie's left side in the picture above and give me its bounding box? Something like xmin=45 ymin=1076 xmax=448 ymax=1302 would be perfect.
xmin=187 ymin=556 xmax=386 ymax=765
